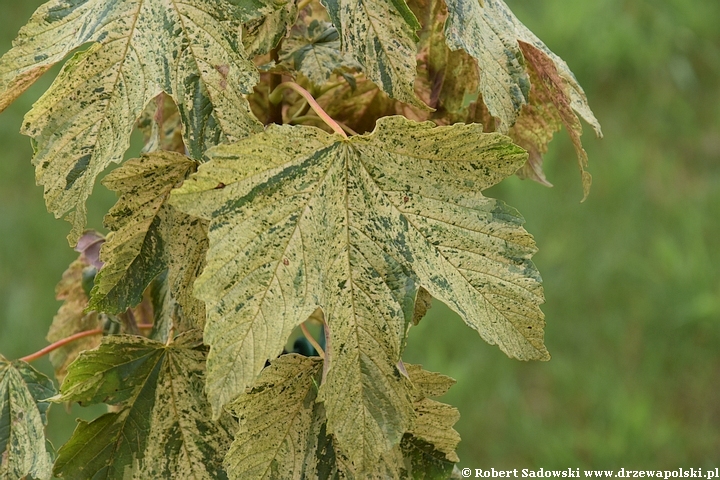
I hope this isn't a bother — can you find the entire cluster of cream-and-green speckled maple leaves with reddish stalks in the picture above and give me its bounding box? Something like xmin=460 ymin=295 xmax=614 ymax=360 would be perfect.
xmin=0 ymin=0 xmax=600 ymax=479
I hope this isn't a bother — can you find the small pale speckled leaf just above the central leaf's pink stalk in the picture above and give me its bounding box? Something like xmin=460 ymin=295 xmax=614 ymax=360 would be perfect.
xmin=280 ymin=19 xmax=359 ymax=85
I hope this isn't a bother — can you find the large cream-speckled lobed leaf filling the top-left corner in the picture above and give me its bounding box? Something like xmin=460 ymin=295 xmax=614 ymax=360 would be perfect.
xmin=0 ymin=0 xmax=258 ymax=245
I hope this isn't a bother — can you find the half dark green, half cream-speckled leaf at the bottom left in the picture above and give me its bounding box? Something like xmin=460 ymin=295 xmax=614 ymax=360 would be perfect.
xmin=53 ymin=334 xmax=234 ymax=479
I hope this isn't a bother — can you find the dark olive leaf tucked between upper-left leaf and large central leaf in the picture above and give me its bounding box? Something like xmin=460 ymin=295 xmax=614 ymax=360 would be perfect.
xmin=90 ymin=151 xmax=207 ymax=332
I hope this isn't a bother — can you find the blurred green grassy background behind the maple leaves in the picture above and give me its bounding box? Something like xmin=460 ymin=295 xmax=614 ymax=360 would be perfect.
xmin=0 ymin=0 xmax=720 ymax=469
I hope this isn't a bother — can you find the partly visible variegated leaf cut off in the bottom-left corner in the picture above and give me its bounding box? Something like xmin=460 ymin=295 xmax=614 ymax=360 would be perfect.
xmin=0 ymin=355 xmax=55 ymax=479
